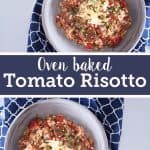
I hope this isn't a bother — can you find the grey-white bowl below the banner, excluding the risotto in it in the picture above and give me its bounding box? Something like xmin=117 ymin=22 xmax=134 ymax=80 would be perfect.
xmin=5 ymin=98 xmax=108 ymax=150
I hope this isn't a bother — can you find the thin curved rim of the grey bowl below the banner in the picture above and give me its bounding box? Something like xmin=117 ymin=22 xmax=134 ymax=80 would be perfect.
xmin=4 ymin=98 xmax=109 ymax=150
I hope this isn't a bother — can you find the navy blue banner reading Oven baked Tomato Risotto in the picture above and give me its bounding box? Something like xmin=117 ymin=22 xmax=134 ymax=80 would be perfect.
xmin=0 ymin=54 xmax=150 ymax=96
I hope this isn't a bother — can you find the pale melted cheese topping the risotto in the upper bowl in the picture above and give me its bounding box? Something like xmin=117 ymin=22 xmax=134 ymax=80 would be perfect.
xmin=78 ymin=0 xmax=109 ymax=25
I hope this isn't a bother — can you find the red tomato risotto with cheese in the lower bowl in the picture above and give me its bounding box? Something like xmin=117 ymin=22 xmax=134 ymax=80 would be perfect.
xmin=19 ymin=115 xmax=94 ymax=150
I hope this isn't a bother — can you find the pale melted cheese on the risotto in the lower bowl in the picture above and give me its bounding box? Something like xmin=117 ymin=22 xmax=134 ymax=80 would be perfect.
xmin=40 ymin=140 xmax=73 ymax=150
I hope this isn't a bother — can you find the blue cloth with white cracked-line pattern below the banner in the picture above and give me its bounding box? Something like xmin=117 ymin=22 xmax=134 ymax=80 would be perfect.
xmin=0 ymin=98 xmax=124 ymax=150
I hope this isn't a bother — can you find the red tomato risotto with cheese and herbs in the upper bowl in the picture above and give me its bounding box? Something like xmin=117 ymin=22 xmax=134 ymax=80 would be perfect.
xmin=56 ymin=0 xmax=132 ymax=50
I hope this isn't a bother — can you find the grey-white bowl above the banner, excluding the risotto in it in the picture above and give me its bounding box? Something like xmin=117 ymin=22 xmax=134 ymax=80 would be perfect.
xmin=42 ymin=0 xmax=146 ymax=52
